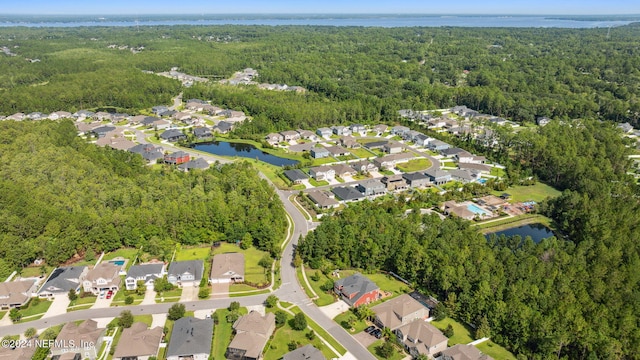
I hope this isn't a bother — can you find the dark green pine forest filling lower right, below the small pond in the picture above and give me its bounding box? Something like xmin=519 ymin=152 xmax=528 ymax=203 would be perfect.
xmin=298 ymin=121 xmax=640 ymax=359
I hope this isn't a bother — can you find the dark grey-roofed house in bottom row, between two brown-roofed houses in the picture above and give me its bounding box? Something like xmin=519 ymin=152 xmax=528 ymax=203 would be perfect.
xmin=166 ymin=317 xmax=213 ymax=360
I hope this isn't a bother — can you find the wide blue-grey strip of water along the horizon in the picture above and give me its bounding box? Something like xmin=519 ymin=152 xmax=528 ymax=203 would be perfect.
xmin=0 ymin=15 xmax=633 ymax=29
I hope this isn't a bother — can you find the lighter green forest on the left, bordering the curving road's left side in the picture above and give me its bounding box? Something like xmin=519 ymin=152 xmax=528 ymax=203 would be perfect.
xmin=0 ymin=121 xmax=286 ymax=277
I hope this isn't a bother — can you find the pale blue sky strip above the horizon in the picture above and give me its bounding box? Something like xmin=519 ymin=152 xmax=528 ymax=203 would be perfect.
xmin=0 ymin=0 xmax=640 ymax=15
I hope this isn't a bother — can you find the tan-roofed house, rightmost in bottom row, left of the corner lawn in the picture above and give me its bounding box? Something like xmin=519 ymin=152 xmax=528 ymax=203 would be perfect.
xmin=225 ymin=311 xmax=276 ymax=360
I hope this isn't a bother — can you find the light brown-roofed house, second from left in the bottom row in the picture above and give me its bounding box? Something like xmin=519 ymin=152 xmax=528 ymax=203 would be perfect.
xmin=51 ymin=319 xmax=105 ymax=360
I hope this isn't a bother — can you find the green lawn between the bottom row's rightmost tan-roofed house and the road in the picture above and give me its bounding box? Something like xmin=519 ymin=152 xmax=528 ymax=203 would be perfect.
xmin=264 ymin=315 xmax=336 ymax=360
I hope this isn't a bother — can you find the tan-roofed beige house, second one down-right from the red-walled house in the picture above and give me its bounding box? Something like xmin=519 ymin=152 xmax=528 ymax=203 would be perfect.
xmin=394 ymin=320 xmax=449 ymax=358
